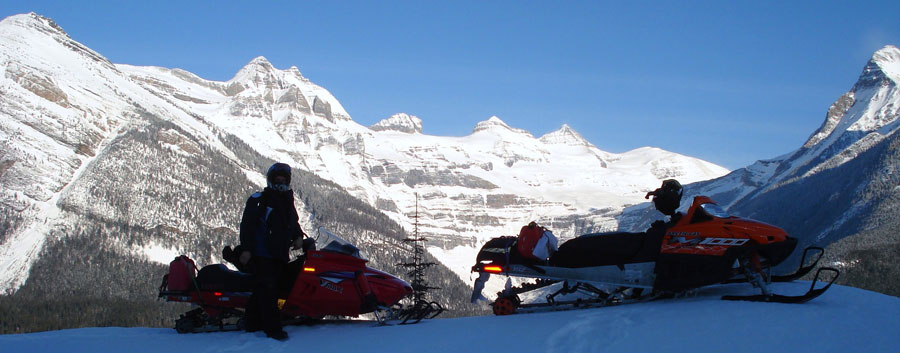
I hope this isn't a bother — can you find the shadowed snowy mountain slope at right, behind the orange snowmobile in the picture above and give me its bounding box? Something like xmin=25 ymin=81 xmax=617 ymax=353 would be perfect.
xmin=619 ymin=46 xmax=900 ymax=280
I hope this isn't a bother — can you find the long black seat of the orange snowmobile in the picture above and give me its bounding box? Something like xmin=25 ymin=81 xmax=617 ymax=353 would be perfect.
xmin=550 ymin=228 xmax=665 ymax=268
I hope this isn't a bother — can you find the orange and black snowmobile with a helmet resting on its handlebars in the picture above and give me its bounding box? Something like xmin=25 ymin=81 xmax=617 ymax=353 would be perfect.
xmin=472 ymin=179 xmax=840 ymax=315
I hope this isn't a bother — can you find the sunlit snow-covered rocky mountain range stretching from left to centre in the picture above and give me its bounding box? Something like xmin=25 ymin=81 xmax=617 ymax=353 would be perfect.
xmin=0 ymin=13 xmax=727 ymax=291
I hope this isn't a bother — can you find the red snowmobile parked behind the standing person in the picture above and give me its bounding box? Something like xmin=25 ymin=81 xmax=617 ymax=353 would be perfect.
xmin=158 ymin=228 xmax=443 ymax=333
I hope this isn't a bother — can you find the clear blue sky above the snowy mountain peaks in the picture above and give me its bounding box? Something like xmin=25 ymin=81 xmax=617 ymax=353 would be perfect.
xmin=0 ymin=0 xmax=900 ymax=169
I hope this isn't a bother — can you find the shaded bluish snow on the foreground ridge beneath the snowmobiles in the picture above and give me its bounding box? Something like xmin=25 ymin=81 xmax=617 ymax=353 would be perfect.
xmin=0 ymin=282 xmax=900 ymax=353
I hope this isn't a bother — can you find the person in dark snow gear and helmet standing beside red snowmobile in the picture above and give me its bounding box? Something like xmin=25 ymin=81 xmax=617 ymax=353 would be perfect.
xmin=239 ymin=163 xmax=305 ymax=340
